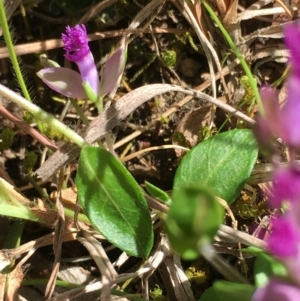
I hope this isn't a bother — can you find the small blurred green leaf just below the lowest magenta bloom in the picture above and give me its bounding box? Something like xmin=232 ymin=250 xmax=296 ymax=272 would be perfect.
xmin=254 ymin=253 xmax=287 ymax=287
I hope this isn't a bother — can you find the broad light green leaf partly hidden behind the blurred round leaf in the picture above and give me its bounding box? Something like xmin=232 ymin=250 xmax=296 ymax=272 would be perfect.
xmin=172 ymin=129 xmax=258 ymax=204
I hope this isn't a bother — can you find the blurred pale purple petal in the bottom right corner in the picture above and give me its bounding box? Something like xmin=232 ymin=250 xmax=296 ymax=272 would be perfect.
xmin=251 ymin=278 xmax=300 ymax=301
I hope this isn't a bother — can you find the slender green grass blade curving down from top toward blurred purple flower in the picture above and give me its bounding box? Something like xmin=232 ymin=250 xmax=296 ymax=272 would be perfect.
xmin=201 ymin=0 xmax=264 ymax=115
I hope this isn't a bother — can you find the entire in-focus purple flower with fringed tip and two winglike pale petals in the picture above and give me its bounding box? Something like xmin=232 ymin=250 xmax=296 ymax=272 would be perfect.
xmin=37 ymin=24 xmax=126 ymax=100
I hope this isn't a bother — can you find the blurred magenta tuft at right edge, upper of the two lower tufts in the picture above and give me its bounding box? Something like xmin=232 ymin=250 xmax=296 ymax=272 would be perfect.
xmin=270 ymin=166 xmax=300 ymax=207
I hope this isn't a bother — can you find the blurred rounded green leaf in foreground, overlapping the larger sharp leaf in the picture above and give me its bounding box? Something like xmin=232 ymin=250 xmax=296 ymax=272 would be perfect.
xmin=166 ymin=186 xmax=224 ymax=260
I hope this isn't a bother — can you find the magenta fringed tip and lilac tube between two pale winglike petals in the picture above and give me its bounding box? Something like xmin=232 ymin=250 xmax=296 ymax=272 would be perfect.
xmin=61 ymin=24 xmax=100 ymax=95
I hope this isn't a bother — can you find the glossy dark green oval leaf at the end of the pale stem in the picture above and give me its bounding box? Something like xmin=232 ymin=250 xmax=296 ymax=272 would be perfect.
xmin=76 ymin=146 xmax=153 ymax=258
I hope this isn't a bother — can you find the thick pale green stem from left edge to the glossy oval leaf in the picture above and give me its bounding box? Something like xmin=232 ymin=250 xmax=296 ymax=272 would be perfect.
xmin=0 ymin=84 xmax=89 ymax=147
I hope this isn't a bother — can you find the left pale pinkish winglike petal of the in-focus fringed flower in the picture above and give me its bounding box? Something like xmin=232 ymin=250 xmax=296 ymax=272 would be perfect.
xmin=37 ymin=68 xmax=86 ymax=98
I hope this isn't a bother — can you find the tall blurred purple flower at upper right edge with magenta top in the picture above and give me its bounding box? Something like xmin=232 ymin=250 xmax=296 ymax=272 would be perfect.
xmin=255 ymin=25 xmax=300 ymax=148
